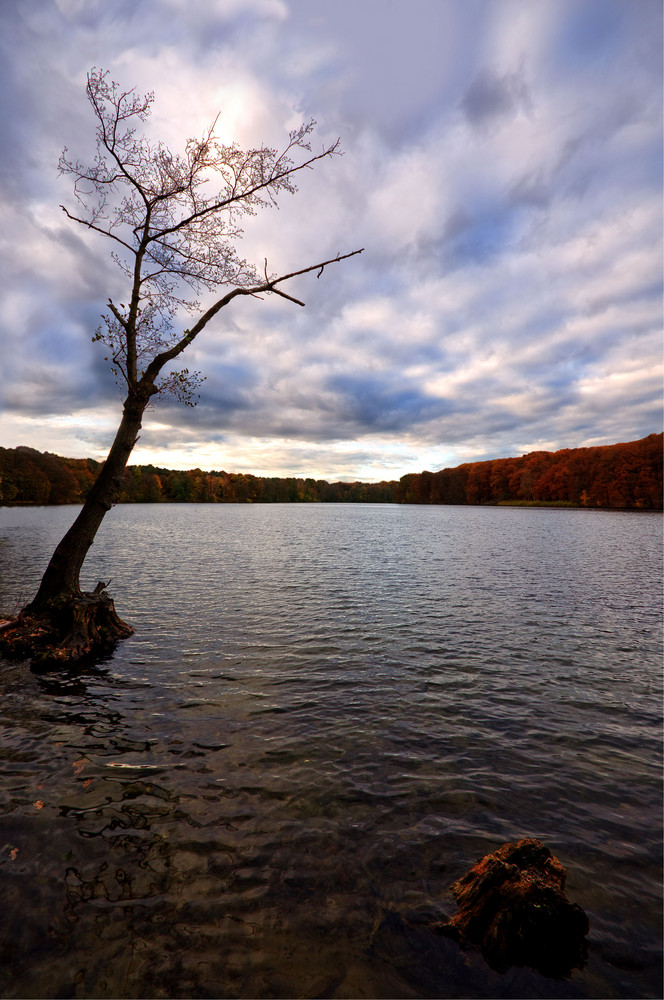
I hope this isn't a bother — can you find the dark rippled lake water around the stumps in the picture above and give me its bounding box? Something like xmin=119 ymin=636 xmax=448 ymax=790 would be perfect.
xmin=0 ymin=505 xmax=662 ymax=998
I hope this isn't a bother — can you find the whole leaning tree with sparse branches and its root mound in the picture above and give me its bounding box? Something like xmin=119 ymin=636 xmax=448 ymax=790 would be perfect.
xmin=0 ymin=69 xmax=362 ymax=661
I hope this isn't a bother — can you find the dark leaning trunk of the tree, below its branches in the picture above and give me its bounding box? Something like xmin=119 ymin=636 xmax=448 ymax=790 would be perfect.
xmin=25 ymin=394 xmax=149 ymax=612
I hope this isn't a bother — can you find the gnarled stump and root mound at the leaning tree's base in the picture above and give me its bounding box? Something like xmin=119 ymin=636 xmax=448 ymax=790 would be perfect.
xmin=0 ymin=581 xmax=134 ymax=668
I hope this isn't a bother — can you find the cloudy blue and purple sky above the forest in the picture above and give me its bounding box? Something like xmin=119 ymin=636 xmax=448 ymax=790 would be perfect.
xmin=0 ymin=0 xmax=663 ymax=481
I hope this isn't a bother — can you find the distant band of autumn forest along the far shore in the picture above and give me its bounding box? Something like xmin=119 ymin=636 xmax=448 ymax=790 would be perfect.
xmin=0 ymin=434 xmax=663 ymax=510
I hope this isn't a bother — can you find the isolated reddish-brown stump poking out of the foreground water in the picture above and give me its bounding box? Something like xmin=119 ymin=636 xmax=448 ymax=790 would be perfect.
xmin=436 ymin=839 xmax=589 ymax=978
